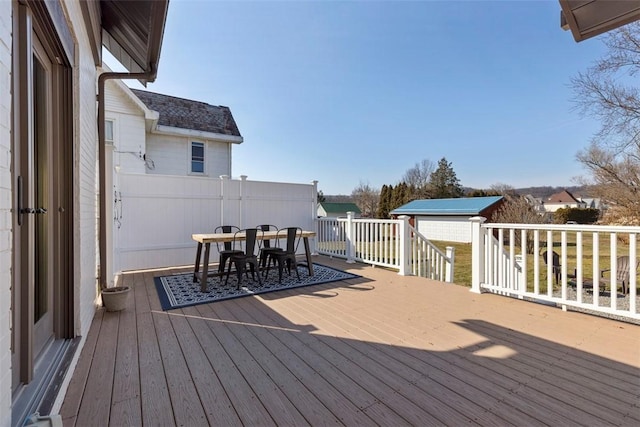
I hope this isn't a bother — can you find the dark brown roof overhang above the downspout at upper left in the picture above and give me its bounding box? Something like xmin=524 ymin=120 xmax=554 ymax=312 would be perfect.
xmin=81 ymin=0 xmax=169 ymax=84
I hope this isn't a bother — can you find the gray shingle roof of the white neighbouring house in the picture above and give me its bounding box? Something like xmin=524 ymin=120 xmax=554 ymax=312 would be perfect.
xmin=131 ymin=89 xmax=241 ymax=136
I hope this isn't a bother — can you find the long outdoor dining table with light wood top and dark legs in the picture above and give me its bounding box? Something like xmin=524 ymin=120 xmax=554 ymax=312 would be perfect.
xmin=191 ymin=230 xmax=316 ymax=292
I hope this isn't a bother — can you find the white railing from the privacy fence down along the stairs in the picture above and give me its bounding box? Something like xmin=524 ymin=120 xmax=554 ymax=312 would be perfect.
xmin=316 ymin=212 xmax=454 ymax=282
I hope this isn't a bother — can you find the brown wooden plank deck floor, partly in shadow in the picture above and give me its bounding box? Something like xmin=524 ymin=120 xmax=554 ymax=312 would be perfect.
xmin=61 ymin=257 xmax=640 ymax=426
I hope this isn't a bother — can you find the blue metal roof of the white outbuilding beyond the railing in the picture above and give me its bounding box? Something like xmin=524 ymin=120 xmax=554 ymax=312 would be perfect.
xmin=391 ymin=196 xmax=502 ymax=215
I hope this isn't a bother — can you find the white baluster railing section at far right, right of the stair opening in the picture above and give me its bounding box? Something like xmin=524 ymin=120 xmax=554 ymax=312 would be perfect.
xmin=471 ymin=217 xmax=640 ymax=319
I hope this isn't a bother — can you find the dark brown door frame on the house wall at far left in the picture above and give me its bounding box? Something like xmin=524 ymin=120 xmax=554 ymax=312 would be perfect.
xmin=11 ymin=0 xmax=75 ymax=393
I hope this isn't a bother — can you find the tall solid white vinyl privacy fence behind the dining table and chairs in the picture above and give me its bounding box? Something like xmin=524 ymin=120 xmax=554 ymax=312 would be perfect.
xmin=112 ymin=173 xmax=317 ymax=273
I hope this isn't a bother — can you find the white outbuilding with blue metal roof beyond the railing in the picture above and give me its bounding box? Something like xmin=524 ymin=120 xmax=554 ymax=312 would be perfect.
xmin=391 ymin=196 xmax=504 ymax=243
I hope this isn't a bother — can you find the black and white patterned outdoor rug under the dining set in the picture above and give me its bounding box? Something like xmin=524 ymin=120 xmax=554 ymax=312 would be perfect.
xmin=154 ymin=263 xmax=360 ymax=311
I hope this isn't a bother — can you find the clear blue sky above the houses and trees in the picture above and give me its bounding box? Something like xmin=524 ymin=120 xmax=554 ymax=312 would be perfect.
xmin=116 ymin=0 xmax=605 ymax=194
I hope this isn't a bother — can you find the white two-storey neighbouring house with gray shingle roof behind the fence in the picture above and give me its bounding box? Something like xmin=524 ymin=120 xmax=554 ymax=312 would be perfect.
xmin=105 ymin=80 xmax=243 ymax=178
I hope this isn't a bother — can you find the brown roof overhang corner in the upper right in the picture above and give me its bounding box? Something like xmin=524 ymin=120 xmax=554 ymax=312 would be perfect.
xmin=559 ymin=0 xmax=640 ymax=42
